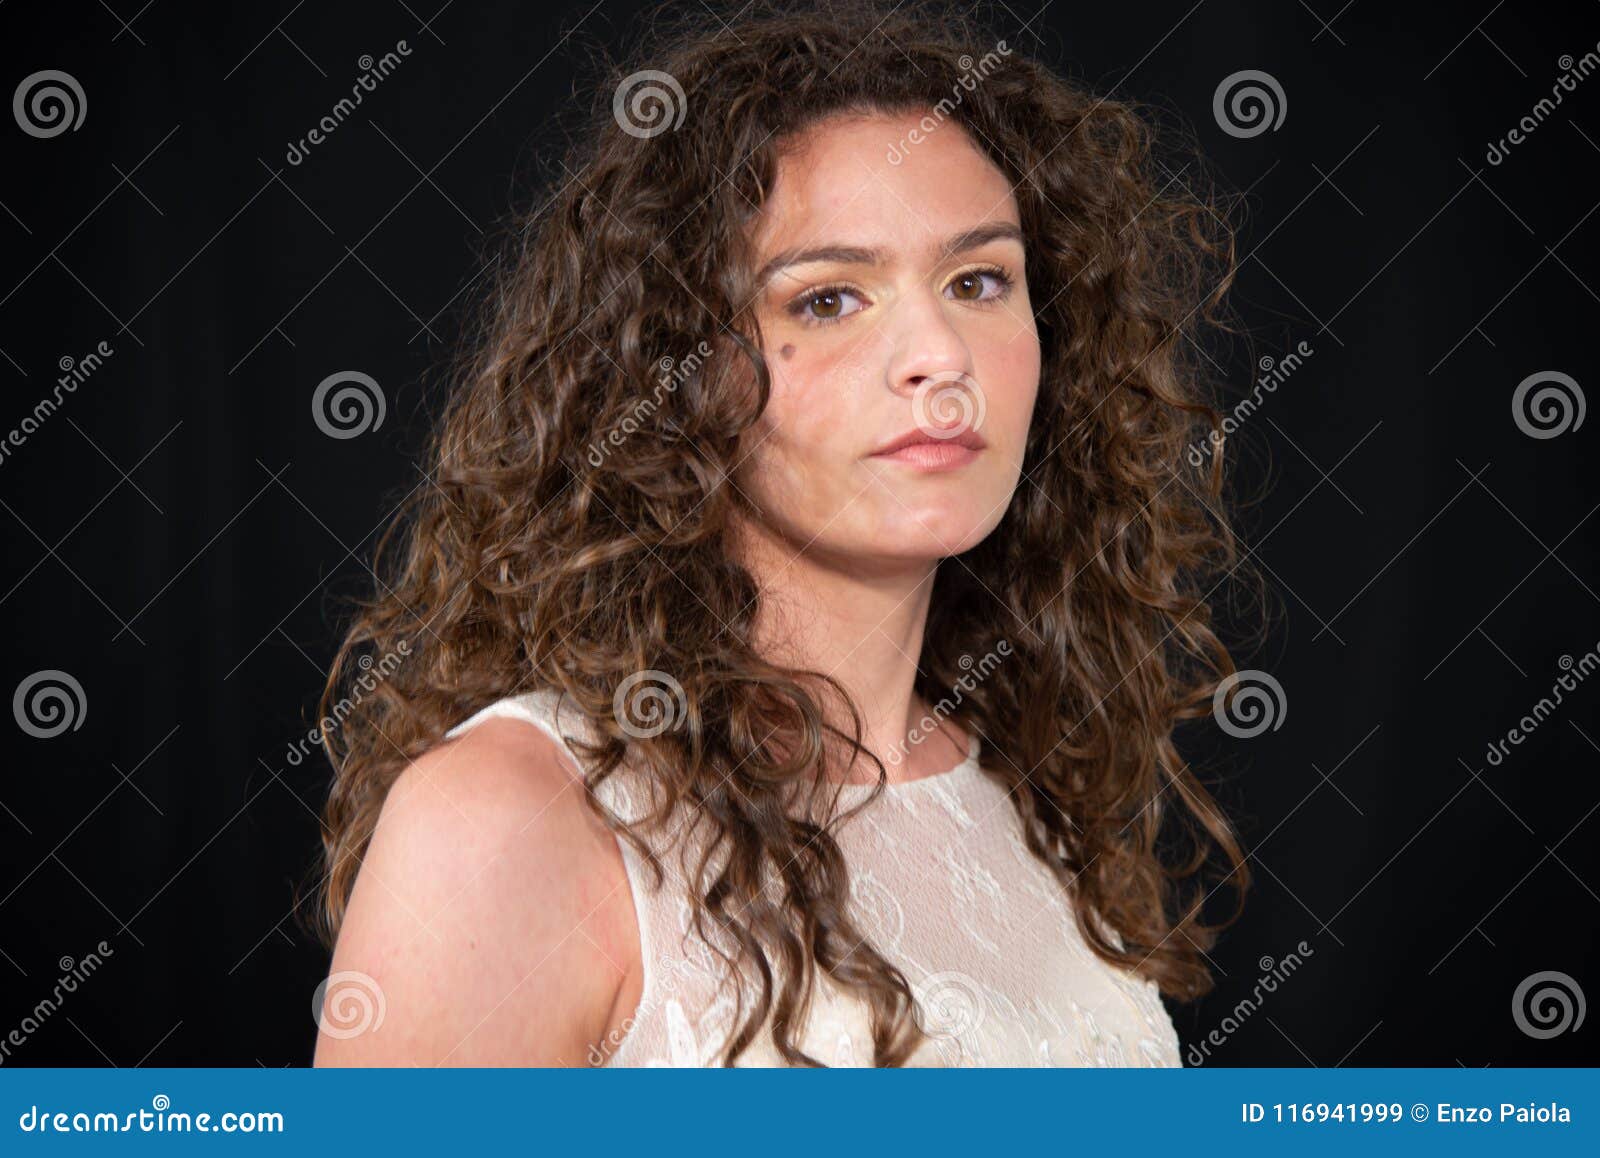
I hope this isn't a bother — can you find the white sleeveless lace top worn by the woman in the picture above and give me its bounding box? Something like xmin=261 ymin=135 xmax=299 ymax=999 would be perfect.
xmin=446 ymin=689 xmax=1182 ymax=1067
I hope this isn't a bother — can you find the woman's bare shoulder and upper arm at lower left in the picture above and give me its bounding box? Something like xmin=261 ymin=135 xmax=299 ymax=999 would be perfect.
xmin=315 ymin=718 xmax=638 ymax=1065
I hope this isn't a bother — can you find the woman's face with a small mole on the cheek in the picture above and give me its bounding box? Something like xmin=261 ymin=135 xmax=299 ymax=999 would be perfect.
xmin=738 ymin=115 xmax=1040 ymax=566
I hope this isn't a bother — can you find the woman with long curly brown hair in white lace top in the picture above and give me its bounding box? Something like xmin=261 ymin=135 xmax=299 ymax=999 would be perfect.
xmin=317 ymin=5 xmax=1245 ymax=1065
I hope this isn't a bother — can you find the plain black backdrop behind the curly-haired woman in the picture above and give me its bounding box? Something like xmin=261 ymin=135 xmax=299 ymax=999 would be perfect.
xmin=0 ymin=0 xmax=1600 ymax=1067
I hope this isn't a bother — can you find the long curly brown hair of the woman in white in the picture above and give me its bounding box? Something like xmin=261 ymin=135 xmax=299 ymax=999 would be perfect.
xmin=305 ymin=2 xmax=1248 ymax=1065
